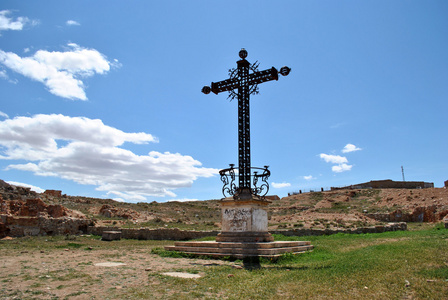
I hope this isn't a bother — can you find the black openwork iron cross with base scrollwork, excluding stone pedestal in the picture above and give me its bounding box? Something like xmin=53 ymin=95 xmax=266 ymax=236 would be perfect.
xmin=202 ymin=48 xmax=291 ymax=200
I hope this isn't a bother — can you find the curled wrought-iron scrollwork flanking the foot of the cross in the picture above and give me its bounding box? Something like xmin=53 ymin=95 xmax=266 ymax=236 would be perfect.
xmin=219 ymin=164 xmax=271 ymax=198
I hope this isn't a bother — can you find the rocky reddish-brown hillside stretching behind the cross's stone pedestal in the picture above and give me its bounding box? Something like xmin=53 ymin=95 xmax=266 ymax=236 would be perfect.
xmin=0 ymin=181 xmax=448 ymax=234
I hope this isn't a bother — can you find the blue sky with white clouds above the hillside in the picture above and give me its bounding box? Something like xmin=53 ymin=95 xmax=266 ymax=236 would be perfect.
xmin=0 ymin=0 xmax=448 ymax=202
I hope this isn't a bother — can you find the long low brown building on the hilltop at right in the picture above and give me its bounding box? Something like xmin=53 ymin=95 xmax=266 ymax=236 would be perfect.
xmin=331 ymin=179 xmax=432 ymax=190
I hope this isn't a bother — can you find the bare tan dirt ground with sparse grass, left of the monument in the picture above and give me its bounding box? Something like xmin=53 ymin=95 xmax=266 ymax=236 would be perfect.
xmin=0 ymin=236 xmax=234 ymax=299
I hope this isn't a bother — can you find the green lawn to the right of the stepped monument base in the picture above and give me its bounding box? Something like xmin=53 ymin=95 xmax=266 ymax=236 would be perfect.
xmin=145 ymin=225 xmax=448 ymax=299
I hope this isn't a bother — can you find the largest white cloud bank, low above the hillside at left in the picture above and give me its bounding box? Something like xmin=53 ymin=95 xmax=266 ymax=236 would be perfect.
xmin=0 ymin=115 xmax=217 ymax=202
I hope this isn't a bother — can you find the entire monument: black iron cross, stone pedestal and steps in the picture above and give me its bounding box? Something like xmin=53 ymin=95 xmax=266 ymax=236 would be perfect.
xmin=165 ymin=49 xmax=313 ymax=258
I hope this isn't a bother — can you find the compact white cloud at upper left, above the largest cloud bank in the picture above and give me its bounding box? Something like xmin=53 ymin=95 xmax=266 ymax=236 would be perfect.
xmin=0 ymin=43 xmax=119 ymax=100
